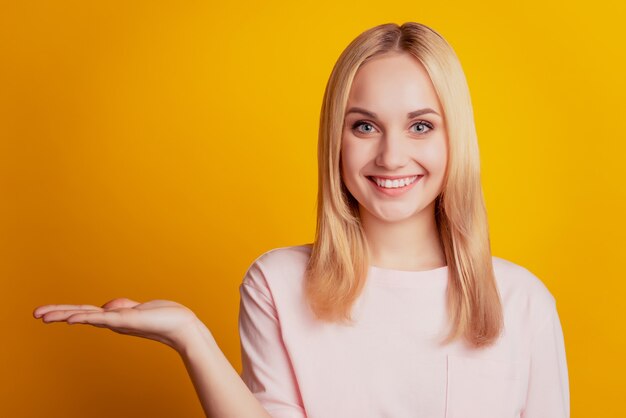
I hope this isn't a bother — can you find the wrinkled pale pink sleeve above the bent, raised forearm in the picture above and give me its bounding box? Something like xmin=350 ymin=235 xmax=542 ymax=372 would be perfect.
xmin=239 ymin=263 xmax=306 ymax=418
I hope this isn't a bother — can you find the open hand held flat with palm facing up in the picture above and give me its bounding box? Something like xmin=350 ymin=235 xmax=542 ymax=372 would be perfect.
xmin=33 ymin=298 xmax=200 ymax=351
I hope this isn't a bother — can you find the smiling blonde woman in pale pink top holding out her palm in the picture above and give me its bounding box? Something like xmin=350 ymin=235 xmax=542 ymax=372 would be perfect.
xmin=34 ymin=22 xmax=569 ymax=418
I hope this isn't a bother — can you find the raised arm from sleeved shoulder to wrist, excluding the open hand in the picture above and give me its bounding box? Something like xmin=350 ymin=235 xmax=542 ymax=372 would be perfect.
xmin=178 ymin=255 xmax=306 ymax=418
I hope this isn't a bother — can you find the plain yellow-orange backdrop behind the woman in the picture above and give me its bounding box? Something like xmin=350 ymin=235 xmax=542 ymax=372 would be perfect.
xmin=0 ymin=0 xmax=626 ymax=418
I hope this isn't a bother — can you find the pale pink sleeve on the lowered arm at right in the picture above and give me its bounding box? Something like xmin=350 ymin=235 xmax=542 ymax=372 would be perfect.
xmin=522 ymin=299 xmax=570 ymax=418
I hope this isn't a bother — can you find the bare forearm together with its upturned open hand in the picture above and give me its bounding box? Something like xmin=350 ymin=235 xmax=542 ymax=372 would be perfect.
xmin=33 ymin=298 xmax=272 ymax=418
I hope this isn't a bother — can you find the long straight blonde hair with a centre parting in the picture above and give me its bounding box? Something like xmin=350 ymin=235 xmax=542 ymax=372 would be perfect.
xmin=305 ymin=22 xmax=503 ymax=347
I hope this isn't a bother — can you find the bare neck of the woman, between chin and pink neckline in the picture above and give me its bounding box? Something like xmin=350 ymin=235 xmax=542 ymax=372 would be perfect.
xmin=360 ymin=202 xmax=446 ymax=271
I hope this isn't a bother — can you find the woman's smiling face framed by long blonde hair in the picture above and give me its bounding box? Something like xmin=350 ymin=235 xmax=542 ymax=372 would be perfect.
xmin=341 ymin=52 xmax=448 ymax=222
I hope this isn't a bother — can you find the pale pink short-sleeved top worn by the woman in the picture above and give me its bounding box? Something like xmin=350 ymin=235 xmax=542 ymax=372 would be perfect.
xmin=239 ymin=245 xmax=570 ymax=418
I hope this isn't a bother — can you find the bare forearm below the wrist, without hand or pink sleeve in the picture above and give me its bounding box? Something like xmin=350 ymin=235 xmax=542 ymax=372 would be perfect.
xmin=178 ymin=320 xmax=271 ymax=418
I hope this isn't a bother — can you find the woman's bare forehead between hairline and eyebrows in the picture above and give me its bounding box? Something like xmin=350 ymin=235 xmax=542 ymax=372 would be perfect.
xmin=348 ymin=52 xmax=441 ymax=118
